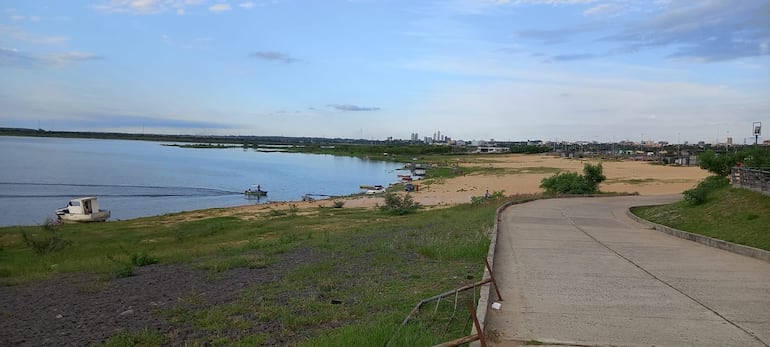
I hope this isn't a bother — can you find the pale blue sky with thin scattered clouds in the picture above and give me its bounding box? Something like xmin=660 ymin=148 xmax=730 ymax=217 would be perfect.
xmin=0 ymin=0 xmax=770 ymax=143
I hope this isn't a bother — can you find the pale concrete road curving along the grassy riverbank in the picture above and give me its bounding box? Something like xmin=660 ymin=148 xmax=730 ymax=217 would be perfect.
xmin=485 ymin=196 xmax=770 ymax=347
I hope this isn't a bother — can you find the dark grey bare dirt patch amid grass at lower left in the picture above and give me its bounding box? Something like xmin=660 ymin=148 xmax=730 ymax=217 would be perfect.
xmin=0 ymin=249 xmax=323 ymax=346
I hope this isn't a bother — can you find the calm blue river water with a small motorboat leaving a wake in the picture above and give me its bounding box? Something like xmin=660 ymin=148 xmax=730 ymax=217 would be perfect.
xmin=0 ymin=136 xmax=403 ymax=226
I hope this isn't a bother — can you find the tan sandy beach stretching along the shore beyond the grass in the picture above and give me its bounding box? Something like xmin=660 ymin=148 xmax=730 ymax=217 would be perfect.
xmin=234 ymin=154 xmax=709 ymax=212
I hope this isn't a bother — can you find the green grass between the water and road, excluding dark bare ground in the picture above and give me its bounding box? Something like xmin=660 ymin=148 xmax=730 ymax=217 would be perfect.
xmin=0 ymin=200 xmax=510 ymax=346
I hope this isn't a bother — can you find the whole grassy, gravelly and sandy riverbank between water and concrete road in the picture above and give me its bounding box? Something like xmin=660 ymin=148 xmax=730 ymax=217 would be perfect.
xmin=0 ymin=155 xmax=705 ymax=346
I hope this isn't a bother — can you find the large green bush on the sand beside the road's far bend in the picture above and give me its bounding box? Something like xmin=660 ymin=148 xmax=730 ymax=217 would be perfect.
xmin=540 ymin=164 xmax=607 ymax=194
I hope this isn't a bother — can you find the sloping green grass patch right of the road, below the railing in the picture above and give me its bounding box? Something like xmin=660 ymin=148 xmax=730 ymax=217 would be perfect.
xmin=632 ymin=186 xmax=770 ymax=251
